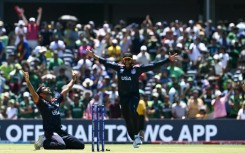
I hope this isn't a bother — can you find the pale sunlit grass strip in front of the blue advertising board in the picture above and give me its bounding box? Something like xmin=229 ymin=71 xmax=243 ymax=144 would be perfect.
xmin=0 ymin=144 xmax=245 ymax=153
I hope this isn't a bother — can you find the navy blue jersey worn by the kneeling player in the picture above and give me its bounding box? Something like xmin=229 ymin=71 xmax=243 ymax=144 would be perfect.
xmin=37 ymin=94 xmax=63 ymax=132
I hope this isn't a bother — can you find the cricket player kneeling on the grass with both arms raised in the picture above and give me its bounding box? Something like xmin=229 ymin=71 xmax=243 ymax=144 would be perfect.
xmin=24 ymin=72 xmax=85 ymax=150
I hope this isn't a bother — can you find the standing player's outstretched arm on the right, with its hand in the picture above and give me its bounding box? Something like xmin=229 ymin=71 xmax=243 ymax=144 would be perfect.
xmin=141 ymin=53 xmax=178 ymax=72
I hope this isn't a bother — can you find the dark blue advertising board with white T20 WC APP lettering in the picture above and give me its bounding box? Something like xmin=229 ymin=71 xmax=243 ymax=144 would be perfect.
xmin=0 ymin=120 xmax=245 ymax=143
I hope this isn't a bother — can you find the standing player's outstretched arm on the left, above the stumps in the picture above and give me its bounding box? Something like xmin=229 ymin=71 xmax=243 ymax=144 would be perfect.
xmin=87 ymin=49 xmax=119 ymax=70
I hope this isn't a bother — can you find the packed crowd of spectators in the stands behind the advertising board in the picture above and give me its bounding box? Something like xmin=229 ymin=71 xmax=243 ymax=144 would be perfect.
xmin=0 ymin=8 xmax=245 ymax=119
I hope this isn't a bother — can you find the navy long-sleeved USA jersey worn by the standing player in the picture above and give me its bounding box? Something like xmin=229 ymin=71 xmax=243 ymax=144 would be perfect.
xmin=99 ymin=58 xmax=169 ymax=95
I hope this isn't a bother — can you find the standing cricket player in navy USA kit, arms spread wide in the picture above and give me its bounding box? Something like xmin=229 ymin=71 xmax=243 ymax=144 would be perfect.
xmin=87 ymin=50 xmax=177 ymax=148
